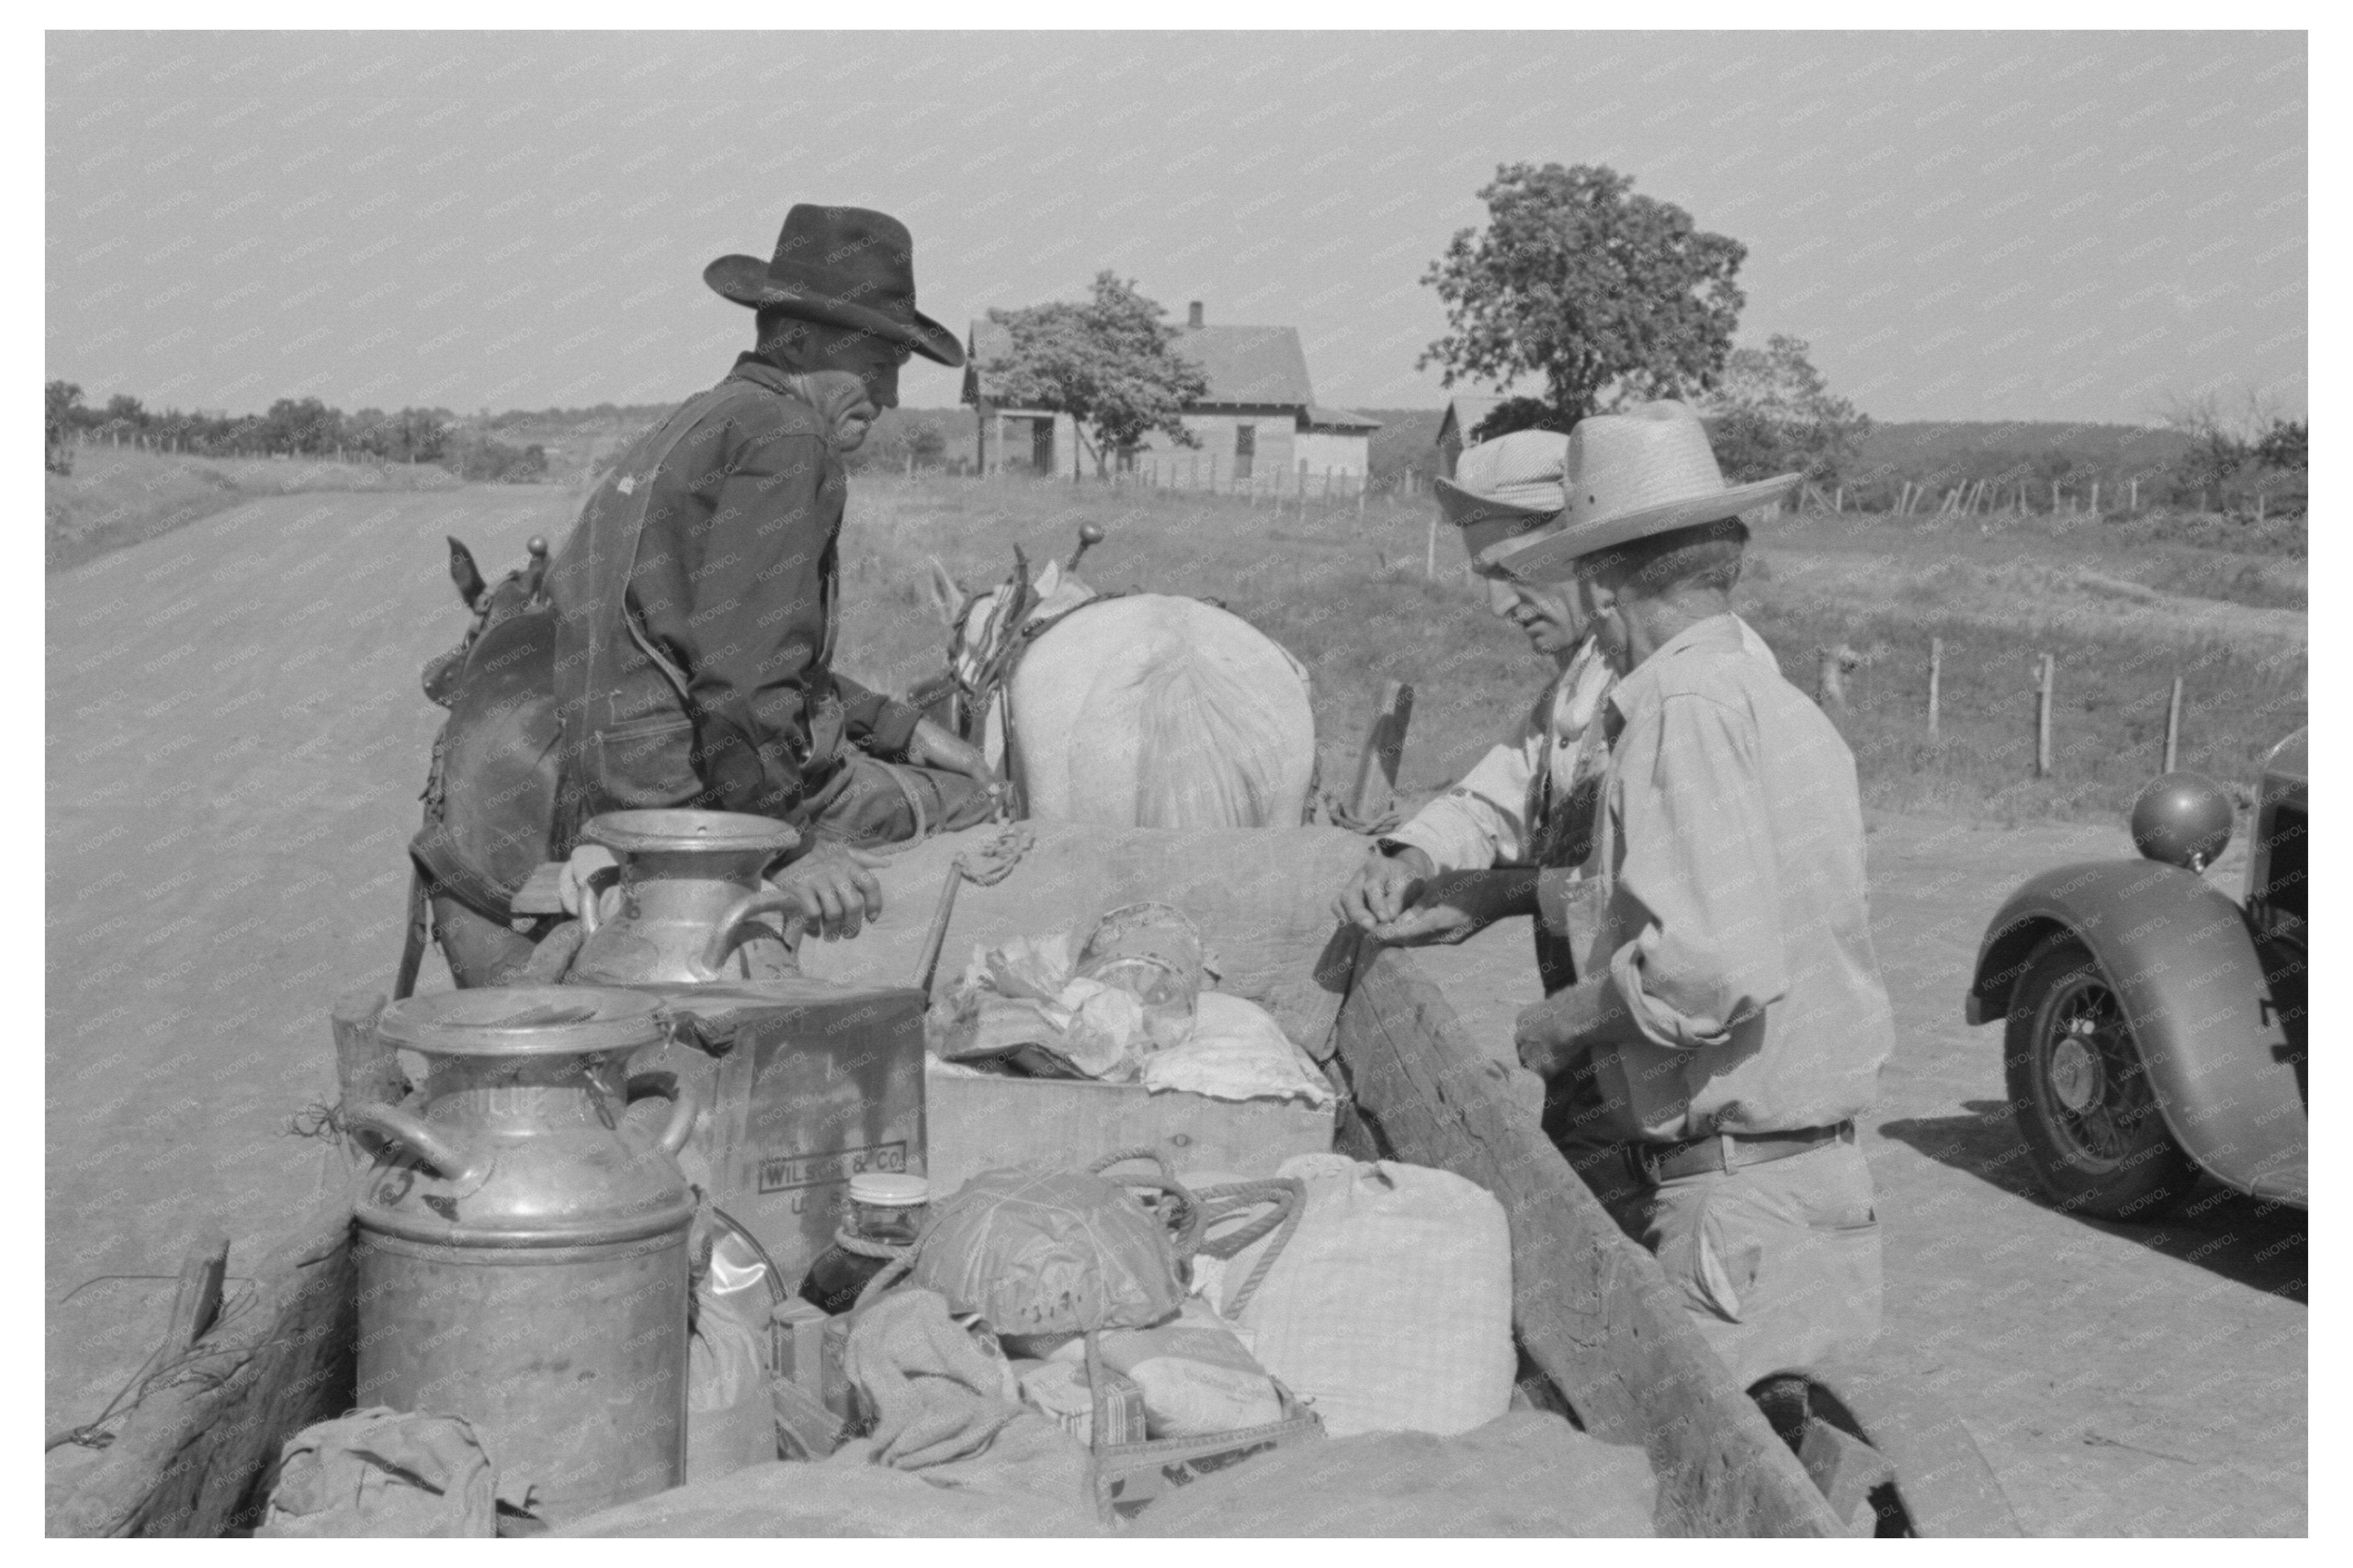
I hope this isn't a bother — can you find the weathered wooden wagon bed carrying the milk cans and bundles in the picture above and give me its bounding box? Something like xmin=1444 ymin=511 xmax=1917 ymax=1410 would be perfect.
xmin=49 ymin=829 xmax=2016 ymax=1535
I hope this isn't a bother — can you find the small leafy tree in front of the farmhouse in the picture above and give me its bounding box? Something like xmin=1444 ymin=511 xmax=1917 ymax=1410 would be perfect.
xmin=981 ymin=271 xmax=1209 ymax=476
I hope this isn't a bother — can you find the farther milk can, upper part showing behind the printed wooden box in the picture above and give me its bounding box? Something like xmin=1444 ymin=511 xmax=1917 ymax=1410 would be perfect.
xmin=567 ymin=810 xmax=800 ymax=987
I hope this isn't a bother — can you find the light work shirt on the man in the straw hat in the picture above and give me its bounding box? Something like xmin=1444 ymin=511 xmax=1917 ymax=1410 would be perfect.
xmin=1541 ymin=615 xmax=1894 ymax=1140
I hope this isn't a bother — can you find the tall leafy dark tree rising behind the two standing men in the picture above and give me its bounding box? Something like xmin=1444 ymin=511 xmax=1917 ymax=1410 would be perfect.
xmin=1417 ymin=163 xmax=1748 ymax=436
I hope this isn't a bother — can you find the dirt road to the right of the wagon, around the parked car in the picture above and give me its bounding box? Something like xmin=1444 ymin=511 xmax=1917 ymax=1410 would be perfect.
xmin=1423 ymin=817 xmax=2308 ymax=1535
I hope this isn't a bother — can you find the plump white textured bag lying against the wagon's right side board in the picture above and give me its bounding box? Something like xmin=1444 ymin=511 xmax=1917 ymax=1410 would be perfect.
xmin=1219 ymin=1154 xmax=1517 ymax=1436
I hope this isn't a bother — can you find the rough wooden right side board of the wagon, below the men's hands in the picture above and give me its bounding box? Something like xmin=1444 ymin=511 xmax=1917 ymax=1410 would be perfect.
xmin=1337 ymin=949 xmax=1842 ymax=1535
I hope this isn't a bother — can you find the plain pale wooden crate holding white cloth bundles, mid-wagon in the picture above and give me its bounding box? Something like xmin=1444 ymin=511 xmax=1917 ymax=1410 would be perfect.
xmin=925 ymin=1067 xmax=1332 ymax=1198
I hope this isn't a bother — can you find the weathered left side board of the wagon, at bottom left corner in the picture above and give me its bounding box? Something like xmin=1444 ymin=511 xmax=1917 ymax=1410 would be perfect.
xmin=47 ymin=1203 xmax=360 ymax=1535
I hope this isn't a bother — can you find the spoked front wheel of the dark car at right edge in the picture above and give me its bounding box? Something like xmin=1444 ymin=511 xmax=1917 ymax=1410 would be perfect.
xmin=2005 ymin=937 xmax=2198 ymax=1222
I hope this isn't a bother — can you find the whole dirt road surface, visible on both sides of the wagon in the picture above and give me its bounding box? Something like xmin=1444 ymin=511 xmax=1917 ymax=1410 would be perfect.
xmin=45 ymin=487 xmax=2306 ymax=1535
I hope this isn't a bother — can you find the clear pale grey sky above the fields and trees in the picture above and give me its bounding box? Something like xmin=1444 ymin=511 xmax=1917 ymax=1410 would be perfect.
xmin=45 ymin=33 xmax=2308 ymax=424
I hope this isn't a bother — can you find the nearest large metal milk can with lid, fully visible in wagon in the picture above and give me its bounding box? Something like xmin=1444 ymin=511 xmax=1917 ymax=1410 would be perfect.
xmin=348 ymin=987 xmax=694 ymax=1521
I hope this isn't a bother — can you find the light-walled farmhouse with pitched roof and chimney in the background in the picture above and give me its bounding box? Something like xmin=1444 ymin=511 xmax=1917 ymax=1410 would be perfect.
xmin=962 ymin=299 xmax=1381 ymax=492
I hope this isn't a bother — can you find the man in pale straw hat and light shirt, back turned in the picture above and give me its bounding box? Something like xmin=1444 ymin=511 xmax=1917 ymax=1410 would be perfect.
xmin=1499 ymin=402 xmax=1894 ymax=1387
